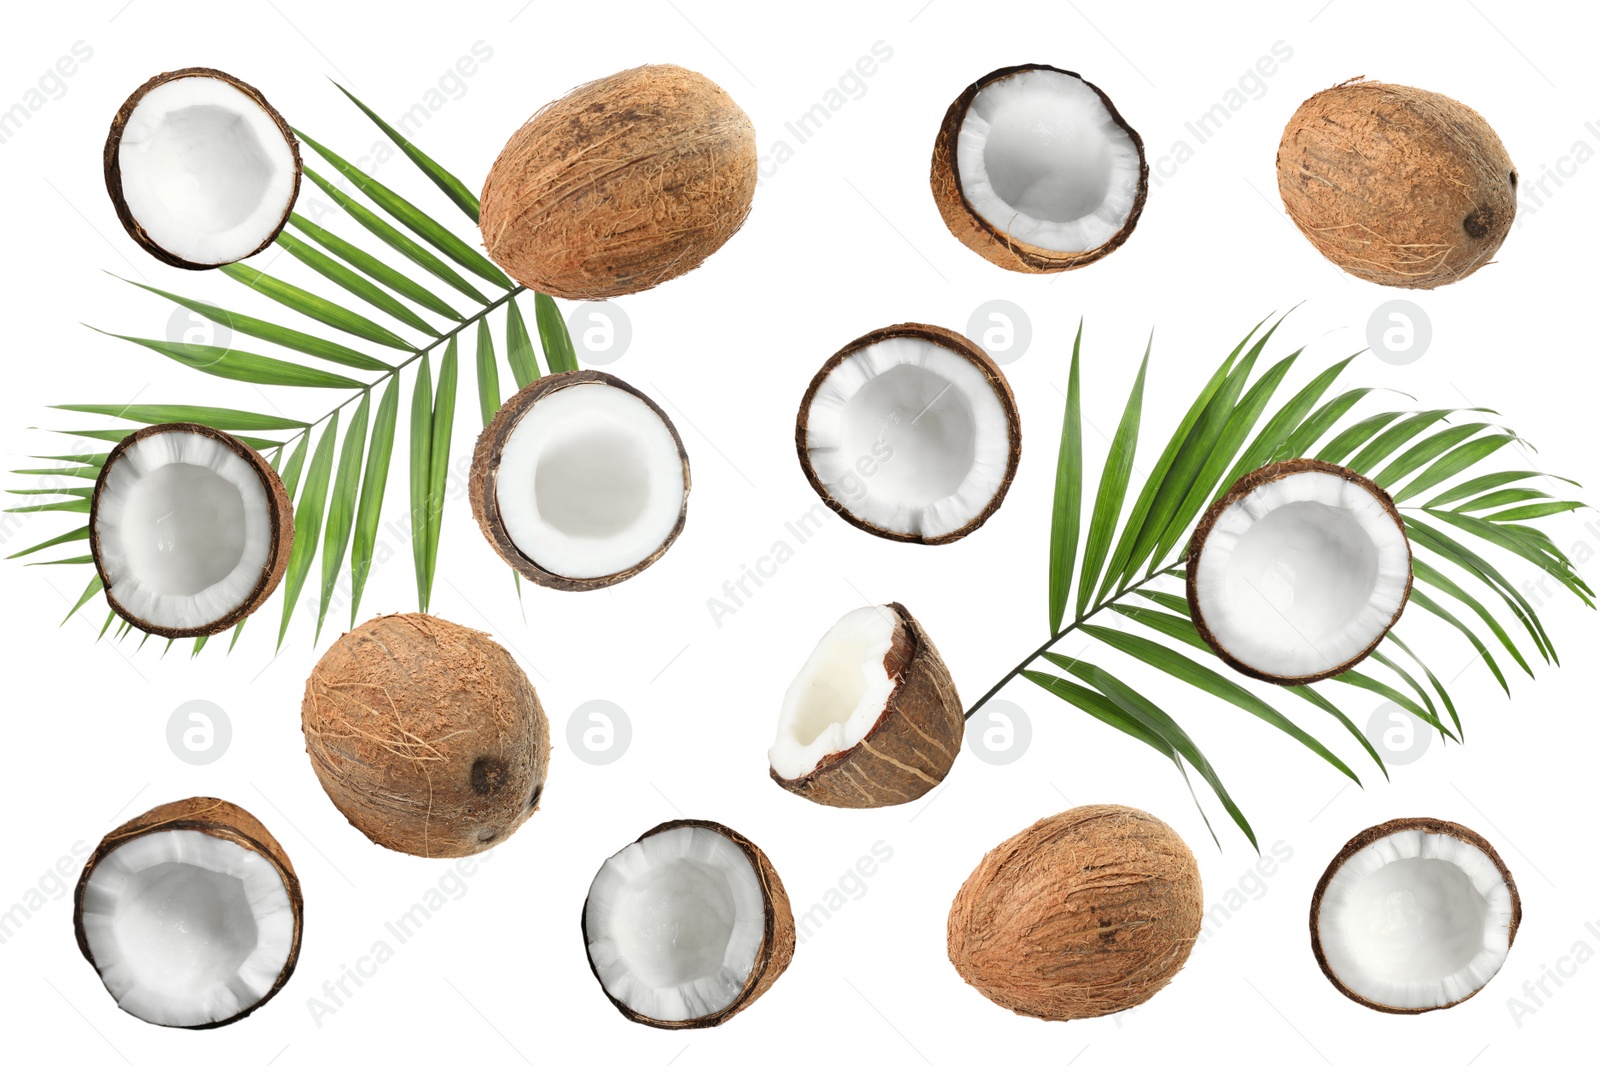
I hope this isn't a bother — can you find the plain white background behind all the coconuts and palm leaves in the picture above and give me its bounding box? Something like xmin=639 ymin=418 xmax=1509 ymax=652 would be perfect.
xmin=0 ymin=0 xmax=1600 ymax=1066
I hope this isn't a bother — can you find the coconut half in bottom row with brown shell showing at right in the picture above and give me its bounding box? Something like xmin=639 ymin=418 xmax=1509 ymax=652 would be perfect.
xmin=582 ymin=820 xmax=795 ymax=1029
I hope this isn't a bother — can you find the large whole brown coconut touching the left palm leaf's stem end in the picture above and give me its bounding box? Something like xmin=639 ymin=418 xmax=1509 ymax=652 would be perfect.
xmin=480 ymin=66 xmax=757 ymax=299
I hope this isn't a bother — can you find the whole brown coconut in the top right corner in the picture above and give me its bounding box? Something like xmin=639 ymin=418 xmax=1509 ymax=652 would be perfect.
xmin=1278 ymin=78 xmax=1517 ymax=288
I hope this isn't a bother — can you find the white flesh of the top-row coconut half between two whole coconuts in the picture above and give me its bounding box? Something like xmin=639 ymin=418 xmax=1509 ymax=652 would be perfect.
xmin=955 ymin=70 xmax=1139 ymax=253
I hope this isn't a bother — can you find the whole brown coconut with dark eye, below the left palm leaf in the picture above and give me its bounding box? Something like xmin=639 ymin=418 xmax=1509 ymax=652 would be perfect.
xmin=301 ymin=615 xmax=550 ymax=858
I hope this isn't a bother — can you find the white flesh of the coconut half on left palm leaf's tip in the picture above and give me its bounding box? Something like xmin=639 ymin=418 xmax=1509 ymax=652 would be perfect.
xmin=94 ymin=431 xmax=272 ymax=629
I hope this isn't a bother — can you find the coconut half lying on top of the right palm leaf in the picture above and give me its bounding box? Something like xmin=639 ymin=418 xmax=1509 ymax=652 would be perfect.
xmin=1187 ymin=459 xmax=1411 ymax=685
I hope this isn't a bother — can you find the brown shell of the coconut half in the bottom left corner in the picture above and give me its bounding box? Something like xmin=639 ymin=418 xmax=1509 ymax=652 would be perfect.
xmin=72 ymin=795 xmax=306 ymax=1029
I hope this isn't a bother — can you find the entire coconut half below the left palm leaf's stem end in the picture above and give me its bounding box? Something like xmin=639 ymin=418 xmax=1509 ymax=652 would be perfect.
xmin=469 ymin=370 xmax=690 ymax=589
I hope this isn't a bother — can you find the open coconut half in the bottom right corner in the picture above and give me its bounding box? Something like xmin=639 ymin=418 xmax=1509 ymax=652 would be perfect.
xmin=1310 ymin=818 xmax=1522 ymax=1015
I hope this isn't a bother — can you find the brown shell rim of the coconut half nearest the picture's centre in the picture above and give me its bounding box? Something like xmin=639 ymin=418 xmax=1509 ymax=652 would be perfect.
xmin=795 ymin=322 xmax=1022 ymax=544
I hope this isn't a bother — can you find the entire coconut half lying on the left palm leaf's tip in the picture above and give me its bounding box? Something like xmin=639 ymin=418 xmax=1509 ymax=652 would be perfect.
xmin=90 ymin=423 xmax=294 ymax=637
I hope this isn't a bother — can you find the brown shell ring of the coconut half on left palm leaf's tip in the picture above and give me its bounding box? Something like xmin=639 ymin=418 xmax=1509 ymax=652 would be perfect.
xmin=90 ymin=423 xmax=294 ymax=639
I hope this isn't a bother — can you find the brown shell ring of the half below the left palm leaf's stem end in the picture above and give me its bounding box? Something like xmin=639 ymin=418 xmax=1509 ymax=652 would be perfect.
xmin=467 ymin=370 xmax=690 ymax=592
